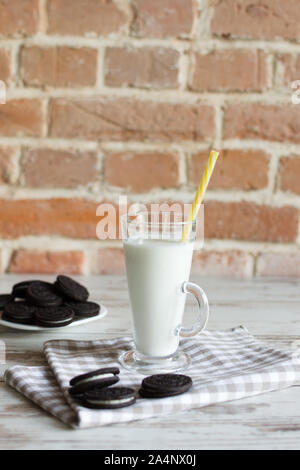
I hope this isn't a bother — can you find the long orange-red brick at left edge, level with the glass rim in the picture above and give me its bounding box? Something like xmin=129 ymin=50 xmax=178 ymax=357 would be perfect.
xmin=0 ymin=199 xmax=100 ymax=239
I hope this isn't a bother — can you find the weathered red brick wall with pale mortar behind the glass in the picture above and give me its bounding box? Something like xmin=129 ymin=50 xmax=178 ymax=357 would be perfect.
xmin=0 ymin=0 xmax=300 ymax=277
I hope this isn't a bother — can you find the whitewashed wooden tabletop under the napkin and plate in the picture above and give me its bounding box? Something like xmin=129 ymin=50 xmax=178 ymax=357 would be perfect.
xmin=0 ymin=275 xmax=300 ymax=450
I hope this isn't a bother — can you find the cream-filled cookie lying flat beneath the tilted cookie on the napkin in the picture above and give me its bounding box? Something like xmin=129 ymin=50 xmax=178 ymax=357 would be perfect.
xmin=82 ymin=387 xmax=136 ymax=409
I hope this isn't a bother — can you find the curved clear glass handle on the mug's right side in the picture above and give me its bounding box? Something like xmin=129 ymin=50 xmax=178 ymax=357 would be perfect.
xmin=178 ymin=282 xmax=209 ymax=338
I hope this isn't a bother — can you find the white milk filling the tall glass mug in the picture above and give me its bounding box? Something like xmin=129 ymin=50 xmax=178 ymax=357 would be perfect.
xmin=124 ymin=240 xmax=193 ymax=357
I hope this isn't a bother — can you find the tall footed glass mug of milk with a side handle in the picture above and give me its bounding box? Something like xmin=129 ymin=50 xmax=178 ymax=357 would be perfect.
xmin=120 ymin=212 xmax=209 ymax=374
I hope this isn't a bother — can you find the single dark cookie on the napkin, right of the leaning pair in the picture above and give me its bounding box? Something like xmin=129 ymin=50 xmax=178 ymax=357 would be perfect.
xmin=139 ymin=374 xmax=193 ymax=398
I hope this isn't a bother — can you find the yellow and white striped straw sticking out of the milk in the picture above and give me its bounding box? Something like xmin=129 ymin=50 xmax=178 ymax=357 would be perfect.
xmin=182 ymin=150 xmax=220 ymax=241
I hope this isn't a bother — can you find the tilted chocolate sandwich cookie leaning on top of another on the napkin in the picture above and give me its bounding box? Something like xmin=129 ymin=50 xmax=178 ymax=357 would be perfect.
xmin=69 ymin=367 xmax=120 ymax=396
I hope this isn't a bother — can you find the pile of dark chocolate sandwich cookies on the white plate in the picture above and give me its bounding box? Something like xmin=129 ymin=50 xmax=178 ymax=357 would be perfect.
xmin=0 ymin=275 xmax=100 ymax=328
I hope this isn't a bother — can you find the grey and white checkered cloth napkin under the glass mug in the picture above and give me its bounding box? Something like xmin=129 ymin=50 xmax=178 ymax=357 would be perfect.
xmin=5 ymin=327 xmax=300 ymax=428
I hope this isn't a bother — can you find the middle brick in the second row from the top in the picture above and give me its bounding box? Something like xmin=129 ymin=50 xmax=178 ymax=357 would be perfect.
xmin=105 ymin=47 xmax=179 ymax=88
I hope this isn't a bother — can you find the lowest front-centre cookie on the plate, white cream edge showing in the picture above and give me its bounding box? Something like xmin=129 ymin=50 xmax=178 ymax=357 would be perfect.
xmin=35 ymin=305 xmax=74 ymax=328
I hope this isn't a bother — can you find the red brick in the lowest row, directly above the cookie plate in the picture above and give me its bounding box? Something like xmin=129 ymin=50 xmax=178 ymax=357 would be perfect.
xmin=8 ymin=249 xmax=84 ymax=274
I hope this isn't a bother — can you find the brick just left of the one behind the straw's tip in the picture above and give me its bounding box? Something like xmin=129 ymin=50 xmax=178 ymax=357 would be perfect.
xmin=104 ymin=151 xmax=179 ymax=193
